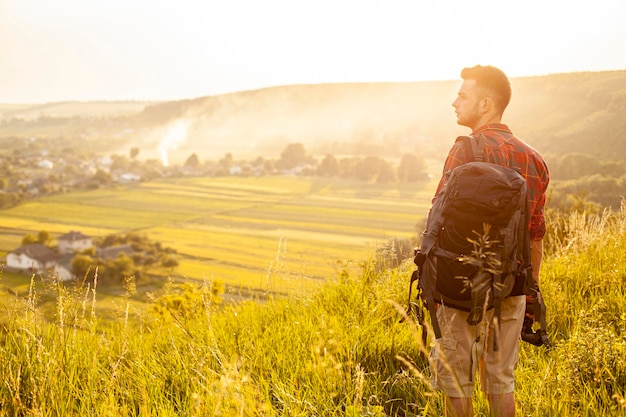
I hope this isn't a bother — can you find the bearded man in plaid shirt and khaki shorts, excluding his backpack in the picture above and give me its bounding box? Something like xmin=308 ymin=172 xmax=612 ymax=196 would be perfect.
xmin=431 ymin=65 xmax=549 ymax=417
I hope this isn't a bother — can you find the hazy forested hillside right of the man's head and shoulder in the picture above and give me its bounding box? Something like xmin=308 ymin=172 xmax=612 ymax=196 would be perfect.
xmin=506 ymin=71 xmax=626 ymax=160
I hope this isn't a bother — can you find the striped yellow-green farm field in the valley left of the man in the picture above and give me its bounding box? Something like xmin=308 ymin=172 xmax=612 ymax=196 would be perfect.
xmin=0 ymin=177 xmax=435 ymax=292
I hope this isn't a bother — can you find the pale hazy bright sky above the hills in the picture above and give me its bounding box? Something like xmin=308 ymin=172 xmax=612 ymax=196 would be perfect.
xmin=0 ymin=0 xmax=626 ymax=103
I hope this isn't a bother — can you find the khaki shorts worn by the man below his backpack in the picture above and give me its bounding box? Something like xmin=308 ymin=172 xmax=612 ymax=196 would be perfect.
xmin=430 ymin=295 xmax=526 ymax=398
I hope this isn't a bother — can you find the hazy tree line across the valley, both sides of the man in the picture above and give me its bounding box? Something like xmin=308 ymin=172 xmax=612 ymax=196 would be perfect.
xmin=0 ymin=132 xmax=626 ymax=210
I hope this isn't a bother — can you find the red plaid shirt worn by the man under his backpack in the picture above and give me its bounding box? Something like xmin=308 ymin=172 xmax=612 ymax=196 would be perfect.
xmin=437 ymin=123 xmax=550 ymax=240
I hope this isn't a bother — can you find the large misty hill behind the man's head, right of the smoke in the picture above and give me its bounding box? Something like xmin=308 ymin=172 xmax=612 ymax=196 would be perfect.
xmin=130 ymin=71 xmax=626 ymax=162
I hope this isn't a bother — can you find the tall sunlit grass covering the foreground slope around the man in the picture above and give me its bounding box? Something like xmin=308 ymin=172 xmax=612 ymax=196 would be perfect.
xmin=0 ymin=202 xmax=626 ymax=416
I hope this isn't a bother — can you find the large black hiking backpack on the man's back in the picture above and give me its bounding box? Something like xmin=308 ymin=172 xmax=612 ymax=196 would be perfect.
xmin=412 ymin=136 xmax=541 ymax=350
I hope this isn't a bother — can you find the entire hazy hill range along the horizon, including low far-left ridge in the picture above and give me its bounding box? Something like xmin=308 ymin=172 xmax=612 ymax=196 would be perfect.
xmin=0 ymin=71 xmax=626 ymax=164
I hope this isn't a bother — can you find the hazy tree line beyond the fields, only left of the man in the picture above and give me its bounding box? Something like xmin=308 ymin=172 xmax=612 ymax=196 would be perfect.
xmin=0 ymin=140 xmax=428 ymax=208
